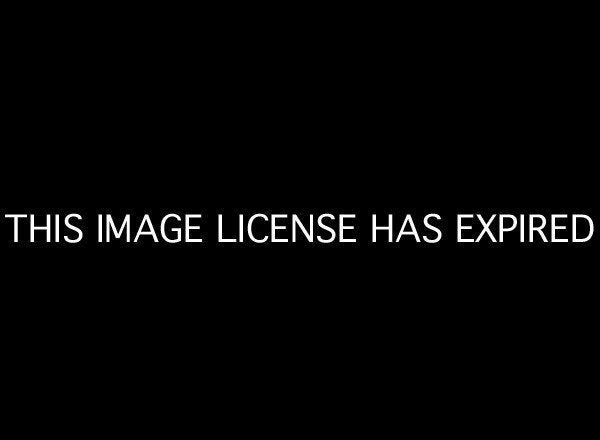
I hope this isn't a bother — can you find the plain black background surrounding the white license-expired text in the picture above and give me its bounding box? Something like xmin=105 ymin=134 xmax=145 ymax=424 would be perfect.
xmin=1 ymin=5 xmax=598 ymax=433
